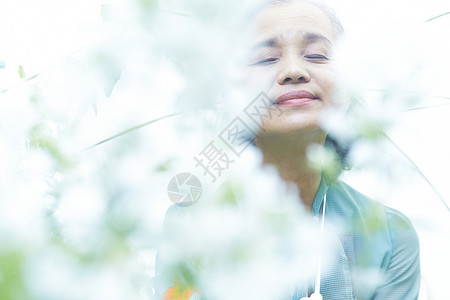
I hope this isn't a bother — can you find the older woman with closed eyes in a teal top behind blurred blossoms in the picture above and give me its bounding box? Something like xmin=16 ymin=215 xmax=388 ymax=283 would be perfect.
xmin=156 ymin=0 xmax=420 ymax=300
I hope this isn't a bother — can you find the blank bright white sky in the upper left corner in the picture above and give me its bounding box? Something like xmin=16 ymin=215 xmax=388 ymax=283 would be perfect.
xmin=0 ymin=0 xmax=105 ymax=90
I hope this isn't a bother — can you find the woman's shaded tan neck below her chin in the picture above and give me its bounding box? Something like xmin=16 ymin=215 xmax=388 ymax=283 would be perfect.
xmin=255 ymin=129 xmax=326 ymax=210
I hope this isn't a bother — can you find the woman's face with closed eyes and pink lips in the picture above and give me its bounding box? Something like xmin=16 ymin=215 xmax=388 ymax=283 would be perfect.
xmin=246 ymin=1 xmax=336 ymax=132
